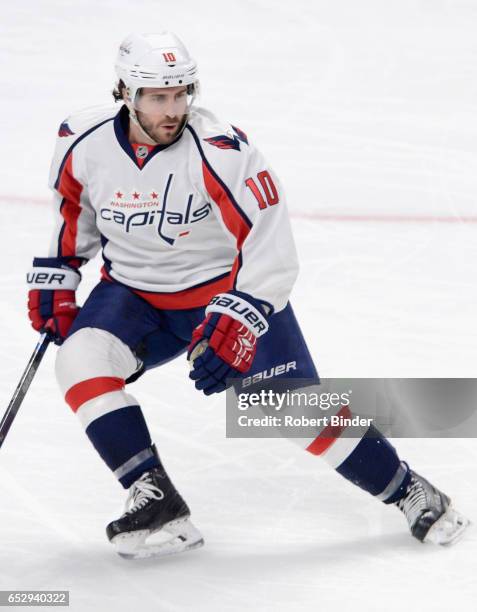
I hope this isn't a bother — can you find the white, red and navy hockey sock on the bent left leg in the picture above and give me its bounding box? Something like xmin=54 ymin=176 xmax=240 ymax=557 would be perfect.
xmin=56 ymin=327 xmax=159 ymax=488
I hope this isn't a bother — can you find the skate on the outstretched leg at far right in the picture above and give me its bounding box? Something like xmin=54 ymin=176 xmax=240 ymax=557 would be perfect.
xmin=396 ymin=470 xmax=470 ymax=545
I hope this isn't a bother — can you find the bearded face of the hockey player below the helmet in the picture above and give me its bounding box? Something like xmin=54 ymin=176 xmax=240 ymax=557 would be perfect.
xmin=134 ymin=87 xmax=191 ymax=144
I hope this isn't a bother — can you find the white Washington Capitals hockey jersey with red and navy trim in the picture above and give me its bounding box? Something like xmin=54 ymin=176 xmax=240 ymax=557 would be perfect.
xmin=49 ymin=105 xmax=298 ymax=311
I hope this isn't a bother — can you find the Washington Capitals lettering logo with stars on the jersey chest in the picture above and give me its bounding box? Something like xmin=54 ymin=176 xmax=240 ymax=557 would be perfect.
xmin=100 ymin=174 xmax=212 ymax=246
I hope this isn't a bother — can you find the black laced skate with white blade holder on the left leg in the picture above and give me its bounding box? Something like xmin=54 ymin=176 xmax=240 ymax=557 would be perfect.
xmin=106 ymin=467 xmax=204 ymax=559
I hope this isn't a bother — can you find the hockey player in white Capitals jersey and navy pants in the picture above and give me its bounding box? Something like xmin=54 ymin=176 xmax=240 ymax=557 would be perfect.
xmin=28 ymin=32 xmax=466 ymax=558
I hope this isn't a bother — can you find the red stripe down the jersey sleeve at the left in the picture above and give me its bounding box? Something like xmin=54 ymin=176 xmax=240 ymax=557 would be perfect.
xmin=58 ymin=153 xmax=83 ymax=257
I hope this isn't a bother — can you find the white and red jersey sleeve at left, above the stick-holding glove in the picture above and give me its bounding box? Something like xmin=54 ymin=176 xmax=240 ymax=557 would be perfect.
xmin=45 ymin=123 xmax=101 ymax=266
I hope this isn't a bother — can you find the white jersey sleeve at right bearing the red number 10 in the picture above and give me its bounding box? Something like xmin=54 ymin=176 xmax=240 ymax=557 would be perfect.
xmin=196 ymin=128 xmax=298 ymax=311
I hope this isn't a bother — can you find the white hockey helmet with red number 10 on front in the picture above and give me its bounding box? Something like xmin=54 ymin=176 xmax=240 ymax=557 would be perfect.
xmin=115 ymin=31 xmax=198 ymax=104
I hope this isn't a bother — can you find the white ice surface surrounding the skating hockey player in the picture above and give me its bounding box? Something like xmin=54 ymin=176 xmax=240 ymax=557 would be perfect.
xmin=0 ymin=0 xmax=477 ymax=612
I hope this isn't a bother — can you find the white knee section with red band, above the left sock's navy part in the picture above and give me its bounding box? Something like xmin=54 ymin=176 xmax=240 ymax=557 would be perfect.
xmin=55 ymin=327 xmax=137 ymax=427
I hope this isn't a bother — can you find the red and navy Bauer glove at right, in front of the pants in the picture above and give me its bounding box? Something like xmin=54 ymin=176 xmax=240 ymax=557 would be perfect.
xmin=187 ymin=293 xmax=268 ymax=395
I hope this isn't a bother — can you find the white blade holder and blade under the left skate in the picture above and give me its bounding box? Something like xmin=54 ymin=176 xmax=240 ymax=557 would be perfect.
xmin=111 ymin=518 xmax=204 ymax=559
